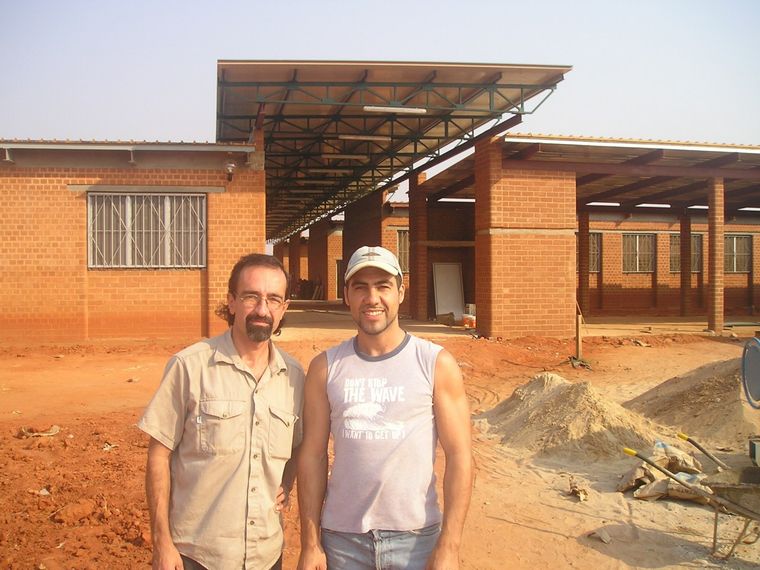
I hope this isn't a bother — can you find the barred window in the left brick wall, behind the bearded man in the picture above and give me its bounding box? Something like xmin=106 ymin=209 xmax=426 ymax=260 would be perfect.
xmin=87 ymin=193 xmax=206 ymax=268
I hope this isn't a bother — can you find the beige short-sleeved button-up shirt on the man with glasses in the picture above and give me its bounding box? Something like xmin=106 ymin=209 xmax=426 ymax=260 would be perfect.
xmin=137 ymin=330 xmax=304 ymax=570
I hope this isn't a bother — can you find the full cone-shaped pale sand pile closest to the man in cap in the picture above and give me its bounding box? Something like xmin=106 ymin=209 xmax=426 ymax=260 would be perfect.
xmin=477 ymin=372 xmax=662 ymax=457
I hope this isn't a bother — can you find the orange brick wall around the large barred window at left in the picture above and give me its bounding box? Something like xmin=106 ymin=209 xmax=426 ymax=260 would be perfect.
xmin=0 ymin=162 xmax=264 ymax=342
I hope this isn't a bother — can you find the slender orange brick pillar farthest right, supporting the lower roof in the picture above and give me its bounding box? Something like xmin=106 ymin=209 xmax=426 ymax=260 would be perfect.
xmin=707 ymin=178 xmax=725 ymax=334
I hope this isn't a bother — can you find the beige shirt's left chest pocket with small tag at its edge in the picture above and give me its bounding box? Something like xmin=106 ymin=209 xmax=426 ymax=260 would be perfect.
xmin=198 ymin=400 xmax=248 ymax=455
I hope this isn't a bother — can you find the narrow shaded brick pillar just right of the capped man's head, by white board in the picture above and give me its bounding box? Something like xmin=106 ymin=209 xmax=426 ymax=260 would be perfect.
xmin=407 ymin=174 xmax=430 ymax=321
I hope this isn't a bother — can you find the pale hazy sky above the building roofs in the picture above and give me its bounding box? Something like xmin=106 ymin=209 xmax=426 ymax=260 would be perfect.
xmin=0 ymin=0 xmax=760 ymax=145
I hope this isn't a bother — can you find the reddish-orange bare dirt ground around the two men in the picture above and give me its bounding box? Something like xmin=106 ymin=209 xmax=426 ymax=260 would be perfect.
xmin=0 ymin=311 xmax=760 ymax=570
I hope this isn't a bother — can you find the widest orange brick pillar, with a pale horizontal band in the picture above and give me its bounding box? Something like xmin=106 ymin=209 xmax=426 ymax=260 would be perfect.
xmin=475 ymin=139 xmax=577 ymax=337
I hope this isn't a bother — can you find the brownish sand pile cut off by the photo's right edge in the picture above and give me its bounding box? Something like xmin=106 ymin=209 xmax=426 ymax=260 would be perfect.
xmin=623 ymin=358 xmax=760 ymax=446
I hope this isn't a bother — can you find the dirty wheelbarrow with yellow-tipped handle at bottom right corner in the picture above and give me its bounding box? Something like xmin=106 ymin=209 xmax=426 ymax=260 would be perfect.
xmin=623 ymin=447 xmax=760 ymax=560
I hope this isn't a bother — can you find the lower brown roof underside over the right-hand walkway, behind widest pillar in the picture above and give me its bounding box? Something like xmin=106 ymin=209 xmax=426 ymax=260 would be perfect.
xmin=422 ymin=135 xmax=760 ymax=216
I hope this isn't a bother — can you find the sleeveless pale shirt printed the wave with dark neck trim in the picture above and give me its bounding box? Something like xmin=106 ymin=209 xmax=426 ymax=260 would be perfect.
xmin=322 ymin=334 xmax=441 ymax=533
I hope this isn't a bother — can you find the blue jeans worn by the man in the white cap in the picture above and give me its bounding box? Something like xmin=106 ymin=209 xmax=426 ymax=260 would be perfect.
xmin=322 ymin=523 xmax=441 ymax=570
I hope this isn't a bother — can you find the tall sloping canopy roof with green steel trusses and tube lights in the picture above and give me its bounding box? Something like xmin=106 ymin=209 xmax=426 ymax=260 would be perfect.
xmin=216 ymin=61 xmax=571 ymax=241
